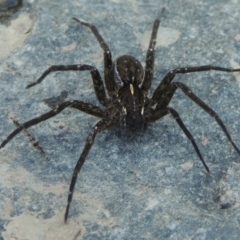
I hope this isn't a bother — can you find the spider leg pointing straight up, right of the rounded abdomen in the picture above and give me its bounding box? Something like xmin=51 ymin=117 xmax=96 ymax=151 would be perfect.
xmin=141 ymin=8 xmax=165 ymax=92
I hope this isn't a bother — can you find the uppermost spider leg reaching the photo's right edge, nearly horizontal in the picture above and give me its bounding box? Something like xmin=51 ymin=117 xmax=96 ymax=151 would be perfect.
xmin=151 ymin=65 xmax=240 ymax=106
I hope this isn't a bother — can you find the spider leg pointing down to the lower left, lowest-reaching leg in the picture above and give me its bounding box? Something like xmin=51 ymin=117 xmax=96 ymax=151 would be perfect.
xmin=64 ymin=118 xmax=117 ymax=223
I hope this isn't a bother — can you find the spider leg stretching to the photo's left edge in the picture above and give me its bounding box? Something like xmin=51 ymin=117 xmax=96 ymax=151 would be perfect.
xmin=0 ymin=100 xmax=104 ymax=149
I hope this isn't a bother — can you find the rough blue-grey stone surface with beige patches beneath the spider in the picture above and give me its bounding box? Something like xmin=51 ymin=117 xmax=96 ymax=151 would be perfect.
xmin=0 ymin=0 xmax=240 ymax=240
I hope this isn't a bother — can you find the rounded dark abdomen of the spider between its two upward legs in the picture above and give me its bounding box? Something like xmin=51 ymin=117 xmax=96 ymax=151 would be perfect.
xmin=113 ymin=55 xmax=143 ymax=87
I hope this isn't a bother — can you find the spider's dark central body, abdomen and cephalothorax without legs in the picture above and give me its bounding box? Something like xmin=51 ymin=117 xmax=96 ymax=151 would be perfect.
xmin=112 ymin=55 xmax=147 ymax=132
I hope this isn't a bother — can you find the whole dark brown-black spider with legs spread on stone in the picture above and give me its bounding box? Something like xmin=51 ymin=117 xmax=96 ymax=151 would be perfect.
xmin=0 ymin=9 xmax=240 ymax=222
